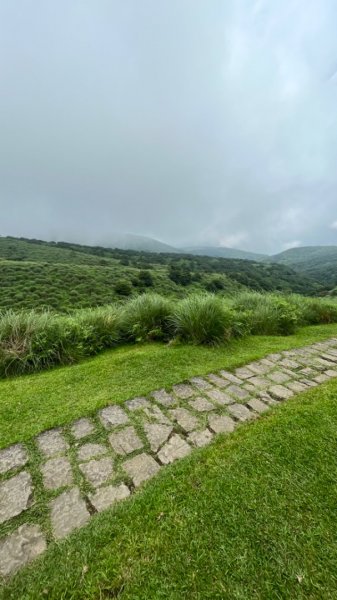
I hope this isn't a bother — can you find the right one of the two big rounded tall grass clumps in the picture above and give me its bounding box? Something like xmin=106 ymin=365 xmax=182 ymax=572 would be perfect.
xmin=172 ymin=294 xmax=235 ymax=345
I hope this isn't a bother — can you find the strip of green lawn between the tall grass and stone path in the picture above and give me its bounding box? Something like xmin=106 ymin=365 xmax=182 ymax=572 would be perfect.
xmin=0 ymin=324 xmax=337 ymax=447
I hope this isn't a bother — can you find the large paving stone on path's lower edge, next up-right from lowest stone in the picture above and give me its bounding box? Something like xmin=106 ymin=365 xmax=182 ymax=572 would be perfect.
xmin=50 ymin=487 xmax=90 ymax=539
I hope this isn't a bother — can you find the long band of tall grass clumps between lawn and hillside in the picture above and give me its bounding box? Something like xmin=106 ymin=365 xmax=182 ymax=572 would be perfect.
xmin=0 ymin=292 xmax=337 ymax=377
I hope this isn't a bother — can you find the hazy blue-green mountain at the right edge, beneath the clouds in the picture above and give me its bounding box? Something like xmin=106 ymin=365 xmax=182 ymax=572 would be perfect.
xmin=264 ymin=246 xmax=337 ymax=290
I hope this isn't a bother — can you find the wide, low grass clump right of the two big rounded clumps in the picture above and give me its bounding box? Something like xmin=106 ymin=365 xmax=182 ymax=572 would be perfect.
xmin=233 ymin=292 xmax=299 ymax=335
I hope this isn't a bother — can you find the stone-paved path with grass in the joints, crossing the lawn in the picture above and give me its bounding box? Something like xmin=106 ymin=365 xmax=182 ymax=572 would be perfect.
xmin=0 ymin=338 xmax=337 ymax=577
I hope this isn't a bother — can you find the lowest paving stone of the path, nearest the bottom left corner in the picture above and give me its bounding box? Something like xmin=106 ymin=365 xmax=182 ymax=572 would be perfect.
xmin=0 ymin=525 xmax=47 ymax=577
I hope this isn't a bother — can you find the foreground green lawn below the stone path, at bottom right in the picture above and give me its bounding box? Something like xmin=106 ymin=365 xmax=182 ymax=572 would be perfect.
xmin=0 ymin=381 xmax=337 ymax=600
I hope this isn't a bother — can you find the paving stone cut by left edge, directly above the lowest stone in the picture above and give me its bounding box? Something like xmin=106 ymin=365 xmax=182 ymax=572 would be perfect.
xmin=0 ymin=471 xmax=33 ymax=524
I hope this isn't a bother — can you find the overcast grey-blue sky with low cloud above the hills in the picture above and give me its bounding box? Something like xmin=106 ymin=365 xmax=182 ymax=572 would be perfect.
xmin=0 ymin=0 xmax=337 ymax=254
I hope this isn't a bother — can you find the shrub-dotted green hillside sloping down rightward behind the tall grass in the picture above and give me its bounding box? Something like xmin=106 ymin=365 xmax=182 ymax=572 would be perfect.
xmin=0 ymin=237 xmax=322 ymax=311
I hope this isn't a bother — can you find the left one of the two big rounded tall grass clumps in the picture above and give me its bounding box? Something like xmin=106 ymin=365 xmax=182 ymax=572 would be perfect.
xmin=122 ymin=292 xmax=173 ymax=341
